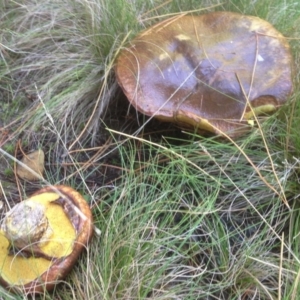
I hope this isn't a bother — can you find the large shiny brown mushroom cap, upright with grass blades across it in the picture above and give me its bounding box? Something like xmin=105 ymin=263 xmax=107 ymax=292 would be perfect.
xmin=115 ymin=12 xmax=292 ymax=137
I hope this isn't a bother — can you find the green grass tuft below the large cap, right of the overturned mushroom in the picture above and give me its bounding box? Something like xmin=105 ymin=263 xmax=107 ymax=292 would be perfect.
xmin=47 ymin=125 xmax=299 ymax=299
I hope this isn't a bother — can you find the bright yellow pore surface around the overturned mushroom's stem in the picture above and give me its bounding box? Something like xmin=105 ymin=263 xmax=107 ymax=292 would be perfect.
xmin=0 ymin=193 xmax=76 ymax=285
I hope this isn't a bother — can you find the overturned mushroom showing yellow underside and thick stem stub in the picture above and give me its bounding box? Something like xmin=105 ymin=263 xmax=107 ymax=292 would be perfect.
xmin=0 ymin=185 xmax=93 ymax=294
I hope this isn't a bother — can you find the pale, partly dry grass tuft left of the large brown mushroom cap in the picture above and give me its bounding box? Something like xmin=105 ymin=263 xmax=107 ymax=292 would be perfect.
xmin=0 ymin=0 xmax=225 ymax=143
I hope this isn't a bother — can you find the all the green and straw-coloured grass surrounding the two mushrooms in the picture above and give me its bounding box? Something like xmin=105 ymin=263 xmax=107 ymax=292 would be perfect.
xmin=0 ymin=0 xmax=300 ymax=300
